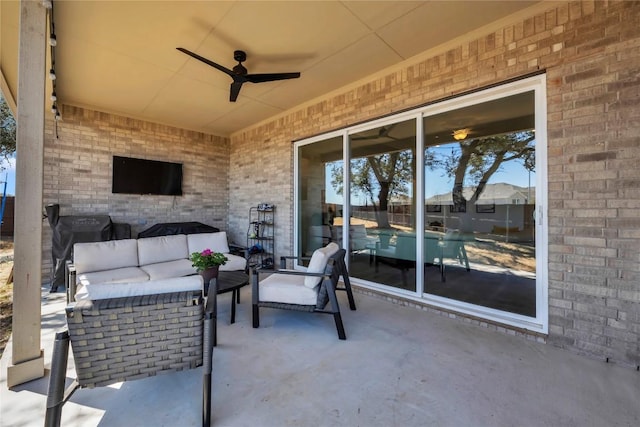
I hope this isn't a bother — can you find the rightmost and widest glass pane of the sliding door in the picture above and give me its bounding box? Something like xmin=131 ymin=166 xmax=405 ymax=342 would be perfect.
xmin=424 ymin=93 xmax=536 ymax=317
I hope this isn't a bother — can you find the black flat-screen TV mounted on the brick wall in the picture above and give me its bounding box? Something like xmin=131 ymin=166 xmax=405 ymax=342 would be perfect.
xmin=111 ymin=156 xmax=182 ymax=196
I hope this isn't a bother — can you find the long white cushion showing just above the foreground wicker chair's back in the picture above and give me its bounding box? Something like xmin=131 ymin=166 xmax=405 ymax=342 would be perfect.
xmin=75 ymin=274 xmax=204 ymax=301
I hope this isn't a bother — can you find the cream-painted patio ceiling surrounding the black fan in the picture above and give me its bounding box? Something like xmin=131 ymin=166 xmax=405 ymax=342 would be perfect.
xmin=0 ymin=0 xmax=537 ymax=136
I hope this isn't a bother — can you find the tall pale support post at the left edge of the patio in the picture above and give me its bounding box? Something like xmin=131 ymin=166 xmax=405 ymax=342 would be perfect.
xmin=7 ymin=0 xmax=47 ymax=387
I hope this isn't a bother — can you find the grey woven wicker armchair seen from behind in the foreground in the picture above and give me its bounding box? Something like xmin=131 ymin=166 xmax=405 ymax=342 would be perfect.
xmin=45 ymin=291 xmax=216 ymax=426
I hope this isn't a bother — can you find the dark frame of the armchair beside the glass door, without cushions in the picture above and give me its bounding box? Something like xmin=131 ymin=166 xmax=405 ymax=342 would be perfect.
xmin=251 ymin=249 xmax=356 ymax=340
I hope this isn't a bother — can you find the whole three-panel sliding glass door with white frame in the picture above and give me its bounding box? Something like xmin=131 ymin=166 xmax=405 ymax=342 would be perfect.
xmin=296 ymin=76 xmax=547 ymax=332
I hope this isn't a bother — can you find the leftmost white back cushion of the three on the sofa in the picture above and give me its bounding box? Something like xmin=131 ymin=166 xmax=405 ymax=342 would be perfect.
xmin=73 ymin=239 xmax=138 ymax=274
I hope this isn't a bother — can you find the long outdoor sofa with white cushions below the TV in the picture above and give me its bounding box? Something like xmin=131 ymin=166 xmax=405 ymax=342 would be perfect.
xmin=65 ymin=231 xmax=247 ymax=302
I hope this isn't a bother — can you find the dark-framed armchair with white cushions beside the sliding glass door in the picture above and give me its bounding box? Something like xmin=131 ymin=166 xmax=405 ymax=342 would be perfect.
xmin=251 ymin=243 xmax=356 ymax=340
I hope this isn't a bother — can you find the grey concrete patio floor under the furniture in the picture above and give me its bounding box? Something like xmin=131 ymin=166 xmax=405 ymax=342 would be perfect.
xmin=0 ymin=288 xmax=640 ymax=427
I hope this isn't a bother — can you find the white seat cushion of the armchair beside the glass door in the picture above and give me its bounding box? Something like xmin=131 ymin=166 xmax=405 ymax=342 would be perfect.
xmin=260 ymin=273 xmax=318 ymax=305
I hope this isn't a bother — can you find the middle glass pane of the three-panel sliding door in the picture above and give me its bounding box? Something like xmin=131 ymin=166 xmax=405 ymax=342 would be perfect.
xmin=338 ymin=120 xmax=416 ymax=291
